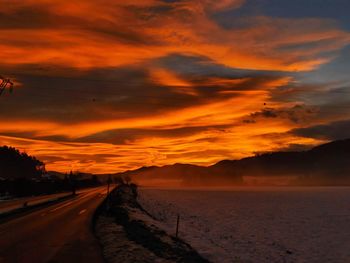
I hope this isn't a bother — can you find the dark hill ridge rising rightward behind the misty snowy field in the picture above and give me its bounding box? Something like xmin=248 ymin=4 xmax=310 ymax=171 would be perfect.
xmin=116 ymin=139 xmax=350 ymax=186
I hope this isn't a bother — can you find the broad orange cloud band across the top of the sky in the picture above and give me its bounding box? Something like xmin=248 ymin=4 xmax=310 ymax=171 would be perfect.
xmin=0 ymin=0 xmax=350 ymax=71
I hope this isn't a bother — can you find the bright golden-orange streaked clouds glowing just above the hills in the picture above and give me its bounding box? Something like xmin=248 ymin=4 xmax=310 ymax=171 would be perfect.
xmin=0 ymin=73 xmax=317 ymax=173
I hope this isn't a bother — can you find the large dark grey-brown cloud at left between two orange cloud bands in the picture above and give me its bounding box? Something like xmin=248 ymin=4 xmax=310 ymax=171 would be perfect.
xmin=0 ymin=68 xmax=202 ymax=123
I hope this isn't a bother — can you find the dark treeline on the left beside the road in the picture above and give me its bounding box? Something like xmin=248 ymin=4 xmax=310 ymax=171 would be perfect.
xmin=0 ymin=146 xmax=101 ymax=197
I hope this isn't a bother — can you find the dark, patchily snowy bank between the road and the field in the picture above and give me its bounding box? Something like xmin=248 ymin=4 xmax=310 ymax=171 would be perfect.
xmin=95 ymin=185 xmax=208 ymax=263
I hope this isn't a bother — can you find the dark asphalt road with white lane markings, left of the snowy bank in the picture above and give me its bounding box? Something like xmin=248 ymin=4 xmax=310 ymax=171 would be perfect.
xmin=0 ymin=187 xmax=106 ymax=263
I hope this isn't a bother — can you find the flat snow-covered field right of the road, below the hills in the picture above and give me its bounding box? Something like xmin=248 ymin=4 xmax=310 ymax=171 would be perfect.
xmin=139 ymin=187 xmax=350 ymax=263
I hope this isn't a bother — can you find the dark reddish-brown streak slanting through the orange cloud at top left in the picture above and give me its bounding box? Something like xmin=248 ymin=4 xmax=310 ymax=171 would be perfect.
xmin=0 ymin=4 xmax=154 ymax=47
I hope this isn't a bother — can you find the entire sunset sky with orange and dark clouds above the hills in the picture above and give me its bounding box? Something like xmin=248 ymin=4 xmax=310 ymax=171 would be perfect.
xmin=0 ymin=0 xmax=350 ymax=173
